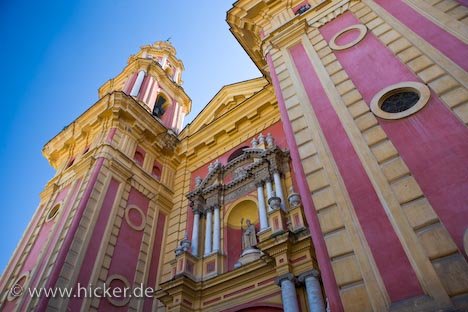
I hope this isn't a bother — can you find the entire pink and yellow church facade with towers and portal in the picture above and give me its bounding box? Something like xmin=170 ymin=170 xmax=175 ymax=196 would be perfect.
xmin=0 ymin=0 xmax=468 ymax=312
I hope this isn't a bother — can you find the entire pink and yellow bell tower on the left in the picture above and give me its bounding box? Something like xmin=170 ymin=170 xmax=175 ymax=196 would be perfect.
xmin=0 ymin=42 xmax=191 ymax=311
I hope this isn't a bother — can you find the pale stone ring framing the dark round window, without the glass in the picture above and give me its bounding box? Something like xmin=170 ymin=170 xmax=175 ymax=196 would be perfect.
xmin=370 ymin=81 xmax=431 ymax=119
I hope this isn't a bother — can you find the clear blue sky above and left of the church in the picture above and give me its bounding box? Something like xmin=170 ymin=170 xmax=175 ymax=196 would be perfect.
xmin=0 ymin=0 xmax=260 ymax=272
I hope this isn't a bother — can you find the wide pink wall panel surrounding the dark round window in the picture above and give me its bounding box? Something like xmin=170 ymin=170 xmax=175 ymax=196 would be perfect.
xmin=321 ymin=13 xmax=468 ymax=254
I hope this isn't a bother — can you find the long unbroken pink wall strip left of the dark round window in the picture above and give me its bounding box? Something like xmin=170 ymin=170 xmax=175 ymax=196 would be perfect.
xmin=290 ymin=40 xmax=423 ymax=302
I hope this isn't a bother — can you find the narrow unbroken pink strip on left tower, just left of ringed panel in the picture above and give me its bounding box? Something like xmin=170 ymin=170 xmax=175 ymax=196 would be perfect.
xmin=68 ymin=179 xmax=120 ymax=311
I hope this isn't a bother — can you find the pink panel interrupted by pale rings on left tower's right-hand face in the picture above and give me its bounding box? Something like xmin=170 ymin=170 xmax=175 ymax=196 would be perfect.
xmin=99 ymin=188 xmax=149 ymax=311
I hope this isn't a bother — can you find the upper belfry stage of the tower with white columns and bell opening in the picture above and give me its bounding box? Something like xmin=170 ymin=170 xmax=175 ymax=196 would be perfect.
xmin=99 ymin=41 xmax=190 ymax=133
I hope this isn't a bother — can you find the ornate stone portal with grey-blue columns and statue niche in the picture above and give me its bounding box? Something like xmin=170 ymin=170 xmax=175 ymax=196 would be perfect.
xmin=156 ymin=134 xmax=323 ymax=311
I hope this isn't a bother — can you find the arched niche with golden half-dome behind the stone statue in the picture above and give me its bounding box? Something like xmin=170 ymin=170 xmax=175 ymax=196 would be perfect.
xmin=224 ymin=197 xmax=259 ymax=271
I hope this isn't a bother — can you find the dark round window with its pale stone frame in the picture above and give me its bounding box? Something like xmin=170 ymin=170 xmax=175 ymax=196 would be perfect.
xmin=370 ymin=81 xmax=431 ymax=119
